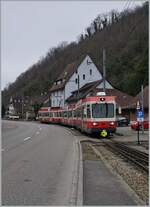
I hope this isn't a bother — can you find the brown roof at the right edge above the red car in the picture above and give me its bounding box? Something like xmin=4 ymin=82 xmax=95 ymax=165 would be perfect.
xmin=124 ymin=86 xmax=149 ymax=109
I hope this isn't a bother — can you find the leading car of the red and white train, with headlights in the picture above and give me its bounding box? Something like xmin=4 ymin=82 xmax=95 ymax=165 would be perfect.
xmin=76 ymin=96 xmax=116 ymax=137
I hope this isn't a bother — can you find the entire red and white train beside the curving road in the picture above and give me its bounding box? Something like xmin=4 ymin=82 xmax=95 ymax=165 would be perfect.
xmin=39 ymin=95 xmax=116 ymax=137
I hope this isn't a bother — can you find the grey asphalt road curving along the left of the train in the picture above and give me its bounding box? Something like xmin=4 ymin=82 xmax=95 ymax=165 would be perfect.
xmin=2 ymin=121 xmax=77 ymax=205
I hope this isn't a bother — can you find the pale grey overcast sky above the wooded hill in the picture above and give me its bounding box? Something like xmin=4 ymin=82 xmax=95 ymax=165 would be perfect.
xmin=1 ymin=0 xmax=143 ymax=89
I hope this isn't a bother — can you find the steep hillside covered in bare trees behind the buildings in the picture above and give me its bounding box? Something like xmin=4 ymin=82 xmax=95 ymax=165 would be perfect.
xmin=2 ymin=2 xmax=149 ymax=105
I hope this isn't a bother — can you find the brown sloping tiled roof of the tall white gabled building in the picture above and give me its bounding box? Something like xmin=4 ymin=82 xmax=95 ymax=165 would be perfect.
xmin=50 ymin=55 xmax=90 ymax=92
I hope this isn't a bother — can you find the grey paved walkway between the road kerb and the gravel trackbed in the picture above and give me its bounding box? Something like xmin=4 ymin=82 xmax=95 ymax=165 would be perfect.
xmin=83 ymin=160 xmax=139 ymax=206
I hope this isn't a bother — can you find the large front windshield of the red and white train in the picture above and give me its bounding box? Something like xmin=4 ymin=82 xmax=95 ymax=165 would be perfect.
xmin=92 ymin=103 xmax=114 ymax=118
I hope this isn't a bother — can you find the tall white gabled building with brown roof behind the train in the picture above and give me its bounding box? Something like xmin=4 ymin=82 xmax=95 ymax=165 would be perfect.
xmin=50 ymin=55 xmax=113 ymax=107
